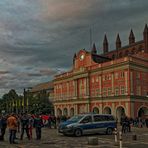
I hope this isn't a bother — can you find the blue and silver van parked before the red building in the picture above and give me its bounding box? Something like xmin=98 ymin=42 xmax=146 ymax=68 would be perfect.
xmin=58 ymin=114 xmax=117 ymax=137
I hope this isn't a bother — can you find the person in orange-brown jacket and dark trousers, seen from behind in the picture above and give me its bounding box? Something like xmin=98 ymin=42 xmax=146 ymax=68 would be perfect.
xmin=7 ymin=114 xmax=17 ymax=144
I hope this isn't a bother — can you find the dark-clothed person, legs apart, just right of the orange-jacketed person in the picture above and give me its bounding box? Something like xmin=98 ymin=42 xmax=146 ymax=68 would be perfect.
xmin=20 ymin=114 xmax=30 ymax=140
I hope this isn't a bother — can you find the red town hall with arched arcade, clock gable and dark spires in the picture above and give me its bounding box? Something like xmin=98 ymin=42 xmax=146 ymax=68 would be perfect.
xmin=54 ymin=25 xmax=148 ymax=120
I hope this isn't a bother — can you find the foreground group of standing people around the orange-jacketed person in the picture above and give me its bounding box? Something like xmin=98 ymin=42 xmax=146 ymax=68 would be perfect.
xmin=0 ymin=113 xmax=44 ymax=144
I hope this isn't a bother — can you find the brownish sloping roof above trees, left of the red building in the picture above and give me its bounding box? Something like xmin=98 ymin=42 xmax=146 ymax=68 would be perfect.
xmin=31 ymin=81 xmax=53 ymax=92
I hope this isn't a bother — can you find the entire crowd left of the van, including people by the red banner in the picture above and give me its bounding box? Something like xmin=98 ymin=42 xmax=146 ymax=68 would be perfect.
xmin=0 ymin=113 xmax=71 ymax=144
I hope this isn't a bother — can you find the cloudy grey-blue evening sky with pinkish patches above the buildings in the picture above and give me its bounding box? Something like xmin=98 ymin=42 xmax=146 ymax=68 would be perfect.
xmin=0 ymin=0 xmax=148 ymax=97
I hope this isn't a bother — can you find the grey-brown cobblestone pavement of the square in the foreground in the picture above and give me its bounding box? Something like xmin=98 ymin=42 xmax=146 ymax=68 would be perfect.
xmin=0 ymin=128 xmax=148 ymax=148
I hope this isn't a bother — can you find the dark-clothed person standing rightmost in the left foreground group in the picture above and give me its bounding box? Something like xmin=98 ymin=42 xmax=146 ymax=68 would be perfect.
xmin=34 ymin=115 xmax=43 ymax=140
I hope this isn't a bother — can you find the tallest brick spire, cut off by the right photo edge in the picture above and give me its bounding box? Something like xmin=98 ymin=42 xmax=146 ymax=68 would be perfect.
xmin=143 ymin=24 xmax=148 ymax=53
